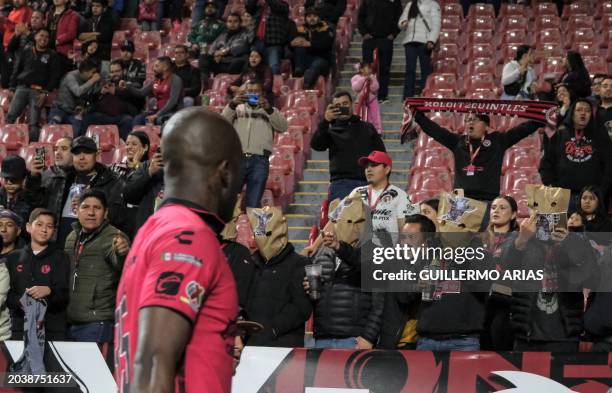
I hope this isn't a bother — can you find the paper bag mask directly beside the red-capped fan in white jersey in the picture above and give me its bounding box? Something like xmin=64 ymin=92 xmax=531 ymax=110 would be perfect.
xmin=329 ymin=196 xmax=365 ymax=244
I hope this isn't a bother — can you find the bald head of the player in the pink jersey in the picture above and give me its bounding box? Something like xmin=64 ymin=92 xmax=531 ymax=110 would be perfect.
xmin=161 ymin=107 xmax=242 ymax=221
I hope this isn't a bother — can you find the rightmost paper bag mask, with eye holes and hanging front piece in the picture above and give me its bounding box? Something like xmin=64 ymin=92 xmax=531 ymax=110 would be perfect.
xmin=525 ymin=184 xmax=571 ymax=241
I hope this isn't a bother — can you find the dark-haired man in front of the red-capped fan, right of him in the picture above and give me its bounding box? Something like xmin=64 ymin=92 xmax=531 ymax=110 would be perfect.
xmin=377 ymin=214 xmax=436 ymax=349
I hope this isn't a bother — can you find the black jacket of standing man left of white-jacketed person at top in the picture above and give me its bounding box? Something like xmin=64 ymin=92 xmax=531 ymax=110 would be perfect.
xmin=357 ymin=0 xmax=403 ymax=38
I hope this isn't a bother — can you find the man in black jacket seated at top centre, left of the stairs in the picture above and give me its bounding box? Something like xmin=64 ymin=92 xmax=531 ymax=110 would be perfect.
xmin=291 ymin=8 xmax=334 ymax=89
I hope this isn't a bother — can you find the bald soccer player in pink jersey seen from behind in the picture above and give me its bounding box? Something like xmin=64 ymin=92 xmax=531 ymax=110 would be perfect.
xmin=115 ymin=107 xmax=242 ymax=393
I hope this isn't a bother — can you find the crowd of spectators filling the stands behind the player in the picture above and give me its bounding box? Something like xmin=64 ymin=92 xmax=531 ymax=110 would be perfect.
xmin=0 ymin=0 xmax=612 ymax=382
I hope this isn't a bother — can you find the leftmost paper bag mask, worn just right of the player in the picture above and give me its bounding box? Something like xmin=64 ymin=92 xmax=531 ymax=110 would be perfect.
xmin=247 ymin=206 xmax=289 ymax=261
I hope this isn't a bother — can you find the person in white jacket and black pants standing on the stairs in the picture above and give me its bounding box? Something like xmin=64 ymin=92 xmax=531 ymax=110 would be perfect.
xmin=396 ymin=0 xmax=441 ymax=99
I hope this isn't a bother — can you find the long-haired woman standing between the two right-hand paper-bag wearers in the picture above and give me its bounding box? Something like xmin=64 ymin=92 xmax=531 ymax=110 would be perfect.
xmin=480 ymin=195 xmax=519 ymax=351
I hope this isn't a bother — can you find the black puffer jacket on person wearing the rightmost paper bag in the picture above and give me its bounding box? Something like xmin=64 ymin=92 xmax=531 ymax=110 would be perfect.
xmin=510 ymin=233 xmax=596 ymax=340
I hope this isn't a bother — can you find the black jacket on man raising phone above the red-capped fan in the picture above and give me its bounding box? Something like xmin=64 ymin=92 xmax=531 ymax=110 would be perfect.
xmin=310 ymin=116 xmax=387 ymax=181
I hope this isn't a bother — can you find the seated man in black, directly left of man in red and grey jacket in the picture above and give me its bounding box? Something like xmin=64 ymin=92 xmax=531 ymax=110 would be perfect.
xmin=80 ymin=60 xmax=138 ymax=140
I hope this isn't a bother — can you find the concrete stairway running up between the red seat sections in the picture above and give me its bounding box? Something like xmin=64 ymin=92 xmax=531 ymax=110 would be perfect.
xmin=286 ymin=33 xmax=412 ymax=250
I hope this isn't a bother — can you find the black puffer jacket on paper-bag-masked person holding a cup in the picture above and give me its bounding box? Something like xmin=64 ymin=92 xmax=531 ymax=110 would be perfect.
xmin=314 ymin=247 xmax=384 ymax=344
